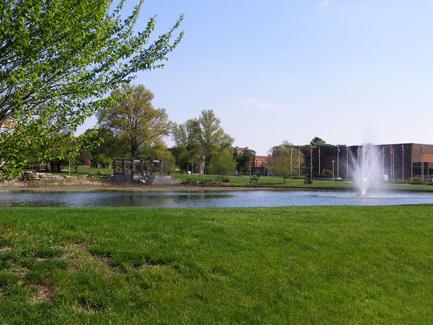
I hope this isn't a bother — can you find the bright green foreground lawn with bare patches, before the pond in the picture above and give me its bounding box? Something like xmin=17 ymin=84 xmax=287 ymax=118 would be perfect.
xmin=0 ymin=206 xmax=433 ymax=324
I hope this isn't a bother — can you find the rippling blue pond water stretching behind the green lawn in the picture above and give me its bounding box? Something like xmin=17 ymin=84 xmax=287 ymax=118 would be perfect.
xmin=0 ymin=191 xmax=433 ymax=208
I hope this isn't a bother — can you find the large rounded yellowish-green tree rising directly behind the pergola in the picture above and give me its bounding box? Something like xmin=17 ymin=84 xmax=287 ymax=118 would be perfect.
xmin=99 ymin=85 xmax=170 ymax=159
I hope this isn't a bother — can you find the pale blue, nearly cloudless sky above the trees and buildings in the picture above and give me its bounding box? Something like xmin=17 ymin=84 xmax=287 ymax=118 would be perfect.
xmin=77 ymin=0 xmax=433 ymax=154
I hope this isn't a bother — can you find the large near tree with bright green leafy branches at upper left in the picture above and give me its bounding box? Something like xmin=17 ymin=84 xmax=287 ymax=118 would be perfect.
xmin=0 ymin=0 xmax=182 ymax=175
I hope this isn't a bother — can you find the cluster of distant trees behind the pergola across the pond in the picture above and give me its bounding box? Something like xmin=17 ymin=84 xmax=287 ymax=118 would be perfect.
xmin=50 ymin=85 xmax=238 ymax=175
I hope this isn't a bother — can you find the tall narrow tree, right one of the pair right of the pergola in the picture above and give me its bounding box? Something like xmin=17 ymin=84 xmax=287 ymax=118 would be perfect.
xmin=198 ymin=110 xmax=233 ymax=161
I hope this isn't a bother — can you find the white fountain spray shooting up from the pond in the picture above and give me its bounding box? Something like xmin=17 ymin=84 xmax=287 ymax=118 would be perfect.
xmin=351 ymin=143 xmax=383 ymax=196
